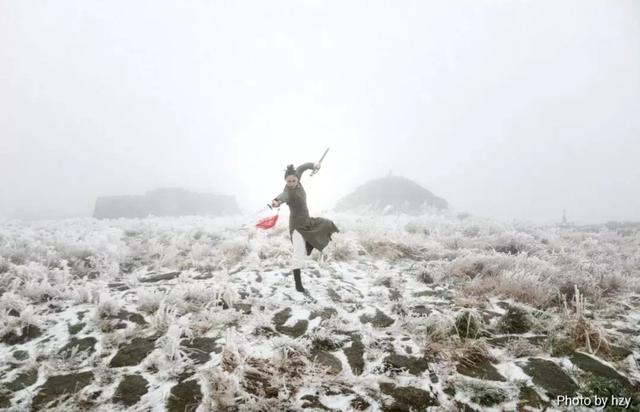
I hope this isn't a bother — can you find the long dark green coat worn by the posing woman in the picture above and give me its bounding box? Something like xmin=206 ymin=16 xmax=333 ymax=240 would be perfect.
xmin=275 ymin=162 xmax=340 ymax=255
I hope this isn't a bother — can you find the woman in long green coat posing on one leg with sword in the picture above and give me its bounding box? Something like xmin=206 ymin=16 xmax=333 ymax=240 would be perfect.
xmin=271 ymin=162 xmax=339 ymax=293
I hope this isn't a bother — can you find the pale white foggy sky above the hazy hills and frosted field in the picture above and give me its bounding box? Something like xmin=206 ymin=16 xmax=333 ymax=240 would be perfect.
xmin=0 ymin=0 xmax=640 ymax=223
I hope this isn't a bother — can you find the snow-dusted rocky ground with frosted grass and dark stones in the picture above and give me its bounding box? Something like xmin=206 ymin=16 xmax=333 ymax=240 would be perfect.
xmin=0 ymin=212 xmax=640 ymax=412
